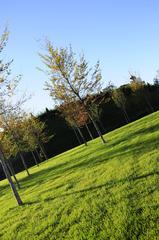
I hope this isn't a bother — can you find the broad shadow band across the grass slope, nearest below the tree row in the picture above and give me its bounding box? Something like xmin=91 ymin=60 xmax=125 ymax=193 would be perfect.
xmin=20 ymin=130 xmax=158 ymax=193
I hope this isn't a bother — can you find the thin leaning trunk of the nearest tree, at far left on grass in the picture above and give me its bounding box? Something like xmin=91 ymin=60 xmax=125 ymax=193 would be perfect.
xmin=0 ymin=150 xmax=23 ymax=206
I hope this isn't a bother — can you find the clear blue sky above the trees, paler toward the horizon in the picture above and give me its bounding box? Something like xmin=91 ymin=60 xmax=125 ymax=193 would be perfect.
xmin=0 ymin=0 xmax=159 ymax=113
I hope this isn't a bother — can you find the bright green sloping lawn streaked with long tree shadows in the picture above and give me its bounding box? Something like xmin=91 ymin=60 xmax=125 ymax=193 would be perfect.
xmin=0 ymin=112 xmax=159 ymax=240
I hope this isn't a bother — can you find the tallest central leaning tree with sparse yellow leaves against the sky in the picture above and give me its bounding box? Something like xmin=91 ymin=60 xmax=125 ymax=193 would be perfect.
xmin=40 ymin=42 xmax=105 ymax=143
